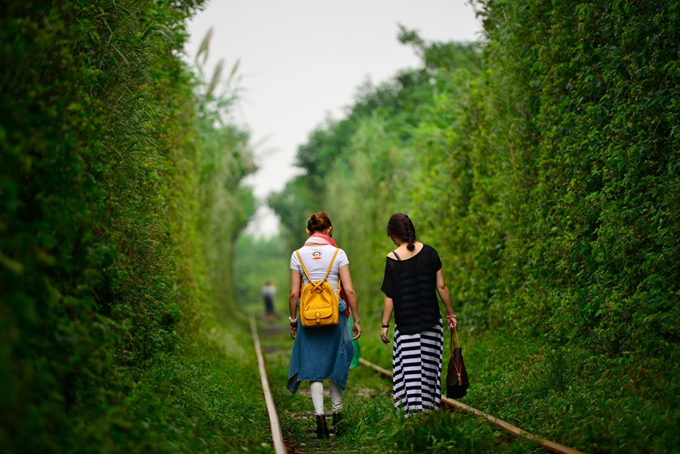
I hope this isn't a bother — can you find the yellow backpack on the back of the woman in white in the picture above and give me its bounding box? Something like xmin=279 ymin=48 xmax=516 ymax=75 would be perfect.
xmin=295 ymin=249 xmax=340 ymax=328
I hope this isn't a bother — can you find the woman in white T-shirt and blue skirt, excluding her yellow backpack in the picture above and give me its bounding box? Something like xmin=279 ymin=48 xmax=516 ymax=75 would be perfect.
xmin=288 ymin=212 xmax=361 ymax=438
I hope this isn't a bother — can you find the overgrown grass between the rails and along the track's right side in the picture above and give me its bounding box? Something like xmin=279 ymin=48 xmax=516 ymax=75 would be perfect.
xmin=244 ymin=274 xmax=680 ymax=453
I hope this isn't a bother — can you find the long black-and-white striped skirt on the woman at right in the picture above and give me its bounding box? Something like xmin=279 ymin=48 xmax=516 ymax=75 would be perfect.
xmin=392 ymin=321 xmax=444 ymax=418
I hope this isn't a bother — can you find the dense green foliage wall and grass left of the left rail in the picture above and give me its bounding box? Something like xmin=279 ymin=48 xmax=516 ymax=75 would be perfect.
xmin=0 ymin=0 xmax=266 ymax=452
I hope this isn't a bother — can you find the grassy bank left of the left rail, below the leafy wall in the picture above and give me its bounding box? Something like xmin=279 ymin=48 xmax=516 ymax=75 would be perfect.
xmin=66 ymin=320 xmax=272 ymax=453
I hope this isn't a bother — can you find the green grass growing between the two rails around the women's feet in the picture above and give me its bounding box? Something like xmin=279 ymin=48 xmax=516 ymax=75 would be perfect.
xmin=253 ymin=306 xmax=542 ymax=453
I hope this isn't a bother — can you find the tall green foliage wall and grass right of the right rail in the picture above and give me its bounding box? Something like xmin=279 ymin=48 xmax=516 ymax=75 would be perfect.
xmin=269 ymin=0 xmax=680 ymax=451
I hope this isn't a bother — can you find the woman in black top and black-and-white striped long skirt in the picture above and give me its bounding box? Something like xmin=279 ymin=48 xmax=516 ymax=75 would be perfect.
xmin=380 ymin=213 xmax=456 ymax=418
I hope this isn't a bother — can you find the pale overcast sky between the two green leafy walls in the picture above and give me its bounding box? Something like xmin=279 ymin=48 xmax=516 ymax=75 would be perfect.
xmin=185 ymin=0 xmax=482 ymax=236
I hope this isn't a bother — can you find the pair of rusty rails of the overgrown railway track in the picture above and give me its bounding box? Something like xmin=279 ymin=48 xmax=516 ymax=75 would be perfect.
xmin=250 ymin=315 xmax=583 ymax=454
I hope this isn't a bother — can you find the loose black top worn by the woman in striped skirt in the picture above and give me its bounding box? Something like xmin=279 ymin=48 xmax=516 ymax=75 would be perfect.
xmin=381 ymin=244 xmax=442 ymax=334
